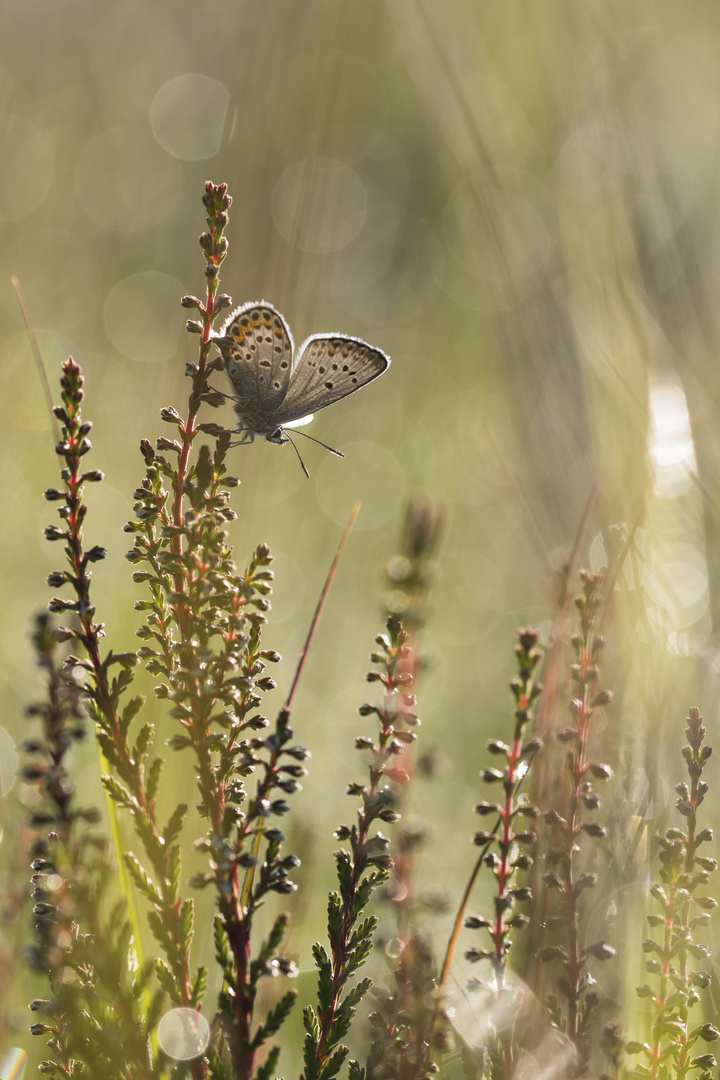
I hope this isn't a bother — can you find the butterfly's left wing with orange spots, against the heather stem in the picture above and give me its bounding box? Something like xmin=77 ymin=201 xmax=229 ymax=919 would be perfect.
xmin=218 ymin=300 xmax=293 ymax=433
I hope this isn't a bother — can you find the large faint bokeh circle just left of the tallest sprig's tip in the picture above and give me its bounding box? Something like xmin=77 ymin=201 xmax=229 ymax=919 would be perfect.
xmin=76 ymin=127 xmax=180 ymax=232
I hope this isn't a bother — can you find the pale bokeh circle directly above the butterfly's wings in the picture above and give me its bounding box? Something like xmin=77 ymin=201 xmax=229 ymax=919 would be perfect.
xmin=272 ymin=158 xmax=367 ymax=254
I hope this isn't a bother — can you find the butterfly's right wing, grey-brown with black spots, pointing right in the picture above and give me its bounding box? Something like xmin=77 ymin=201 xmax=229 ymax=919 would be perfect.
xmin=275 ymin=334 xmax=390 ymax=427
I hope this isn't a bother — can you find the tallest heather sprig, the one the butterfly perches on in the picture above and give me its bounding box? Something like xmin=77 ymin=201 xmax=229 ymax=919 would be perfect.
xmin=126 ymin=184 xmax=307 ymax=1077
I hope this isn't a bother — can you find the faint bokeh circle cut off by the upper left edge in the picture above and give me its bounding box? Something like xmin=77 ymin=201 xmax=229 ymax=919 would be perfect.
xmin=0 ymin=112 xmax=53 ymax=221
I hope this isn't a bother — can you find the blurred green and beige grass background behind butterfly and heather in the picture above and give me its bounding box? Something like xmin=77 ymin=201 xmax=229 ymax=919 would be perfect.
xmin=0 ymin=0 xmax=720 ymax=1071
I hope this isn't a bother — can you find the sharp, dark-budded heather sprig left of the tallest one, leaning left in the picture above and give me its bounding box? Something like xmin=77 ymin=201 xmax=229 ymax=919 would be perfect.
xmin=39 ymin=349 xmax=205 ymax=1077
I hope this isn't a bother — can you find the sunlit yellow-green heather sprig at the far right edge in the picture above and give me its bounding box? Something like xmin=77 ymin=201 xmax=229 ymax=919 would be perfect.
xmin=625 ymin=706 xmax=720 ymax=1080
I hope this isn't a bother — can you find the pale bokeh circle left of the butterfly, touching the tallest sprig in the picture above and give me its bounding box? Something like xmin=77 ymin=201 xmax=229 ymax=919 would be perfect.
xmin=105 ymin=270 xmax=182 ymax=363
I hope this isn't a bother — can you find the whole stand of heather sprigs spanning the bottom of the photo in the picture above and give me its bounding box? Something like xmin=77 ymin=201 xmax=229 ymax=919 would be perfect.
xmin=0 ymin=183 xmax=718 ymax=1080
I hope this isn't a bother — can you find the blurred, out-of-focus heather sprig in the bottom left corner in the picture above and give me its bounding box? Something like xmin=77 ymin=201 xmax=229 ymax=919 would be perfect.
xmin=23 ymin=615 xmax=162 ymax=1080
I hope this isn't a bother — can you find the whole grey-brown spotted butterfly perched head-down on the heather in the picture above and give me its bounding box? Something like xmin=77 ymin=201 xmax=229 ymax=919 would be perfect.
xmin=215 ymin=300 xmax=390 ymax=475
